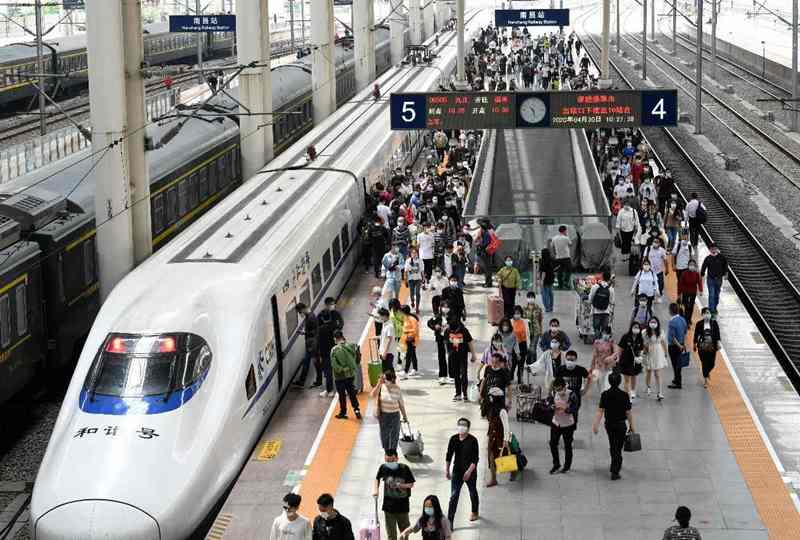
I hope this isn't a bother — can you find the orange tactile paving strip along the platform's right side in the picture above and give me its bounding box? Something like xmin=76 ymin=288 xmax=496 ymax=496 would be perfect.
xmin=665 ymin=272 xmax=800 ymax=540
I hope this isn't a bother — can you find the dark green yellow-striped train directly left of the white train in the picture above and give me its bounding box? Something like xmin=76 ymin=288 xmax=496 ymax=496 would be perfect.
xmin=0 ymin=28 xmax=390 ymax=410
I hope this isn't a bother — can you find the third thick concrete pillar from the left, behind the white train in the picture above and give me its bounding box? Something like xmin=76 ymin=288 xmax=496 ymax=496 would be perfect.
xmin=311 ymin=0 xmax=336 ymax=124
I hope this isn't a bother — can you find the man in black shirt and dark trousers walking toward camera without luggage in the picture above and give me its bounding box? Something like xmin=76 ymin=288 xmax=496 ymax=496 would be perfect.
xmin=444 ymin=418 xmax=479 ymax=529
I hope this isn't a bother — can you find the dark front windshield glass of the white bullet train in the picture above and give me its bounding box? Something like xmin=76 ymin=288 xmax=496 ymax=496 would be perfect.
xmin=84 ymin=333 xmax=211 ymax=399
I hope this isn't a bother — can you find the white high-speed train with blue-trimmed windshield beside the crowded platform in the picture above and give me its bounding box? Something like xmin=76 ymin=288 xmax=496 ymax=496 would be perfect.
xmin=30 ymin=11 xmax=488 ymax=540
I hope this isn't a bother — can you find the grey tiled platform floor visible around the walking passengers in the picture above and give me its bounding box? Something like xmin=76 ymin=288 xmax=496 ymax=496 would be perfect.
xmin=209 ymin=240 xmax=800 ymax=540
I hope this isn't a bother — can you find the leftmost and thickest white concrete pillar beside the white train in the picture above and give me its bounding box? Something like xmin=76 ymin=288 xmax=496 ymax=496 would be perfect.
xmin=86 ymin=0 xmax=134 ymax=299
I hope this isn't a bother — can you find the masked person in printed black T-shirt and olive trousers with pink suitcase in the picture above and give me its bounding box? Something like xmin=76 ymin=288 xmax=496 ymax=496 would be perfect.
xmin=372 ymin=450 xmax=416 ymax=540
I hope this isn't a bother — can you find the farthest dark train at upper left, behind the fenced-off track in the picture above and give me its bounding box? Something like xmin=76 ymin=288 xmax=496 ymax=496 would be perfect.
xmin=0 ymin=23 xmax=300 ymax=107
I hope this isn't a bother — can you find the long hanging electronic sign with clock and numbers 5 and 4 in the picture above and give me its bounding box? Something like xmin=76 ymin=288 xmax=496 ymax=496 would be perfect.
xmin=390 ymin=90 xmax=678 ymax=130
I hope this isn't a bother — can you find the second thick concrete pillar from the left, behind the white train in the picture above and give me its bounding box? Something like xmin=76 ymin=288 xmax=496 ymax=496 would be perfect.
xmin=236 ymin=0 xmax=273 ymax=180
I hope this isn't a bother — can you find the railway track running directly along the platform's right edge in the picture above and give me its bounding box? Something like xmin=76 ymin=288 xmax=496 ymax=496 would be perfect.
xmin=583 ymin=17 xmax=800 ymax=391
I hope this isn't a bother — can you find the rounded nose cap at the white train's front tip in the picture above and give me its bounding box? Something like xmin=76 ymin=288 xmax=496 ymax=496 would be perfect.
xmin=34 ymin=500 xmax=161 ymax=540
